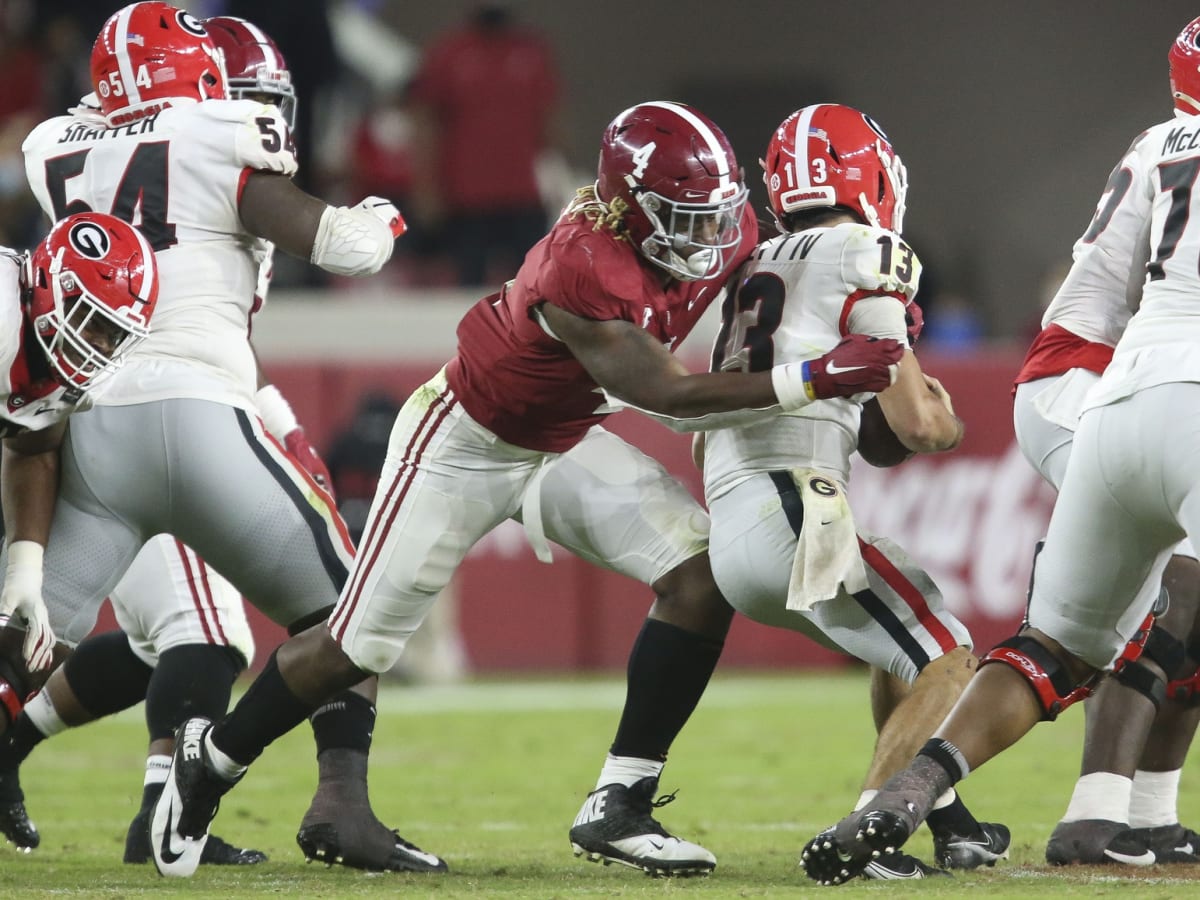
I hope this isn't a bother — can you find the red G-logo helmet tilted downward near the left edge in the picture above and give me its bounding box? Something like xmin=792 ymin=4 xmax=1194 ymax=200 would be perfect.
xmin=25 ymin=212 xmax=158 ymax=389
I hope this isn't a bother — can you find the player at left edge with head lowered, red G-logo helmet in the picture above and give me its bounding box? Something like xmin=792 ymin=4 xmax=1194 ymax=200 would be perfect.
xmin=0 ymin=212 xmax=158 ymax=848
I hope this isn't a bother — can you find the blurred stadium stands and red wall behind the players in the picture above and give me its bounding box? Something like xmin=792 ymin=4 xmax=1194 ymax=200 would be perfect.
xmin=9 ymin=0 xmax=1196 ymax=673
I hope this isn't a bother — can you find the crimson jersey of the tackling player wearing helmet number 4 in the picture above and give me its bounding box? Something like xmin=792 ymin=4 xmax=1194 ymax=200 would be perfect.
xmin=446 ymin=196 xmax=758 ymax=452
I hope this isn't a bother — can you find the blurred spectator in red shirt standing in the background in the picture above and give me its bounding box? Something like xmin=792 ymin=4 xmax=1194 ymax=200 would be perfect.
xmin=406 ymin=4 xmax=558 ymax=284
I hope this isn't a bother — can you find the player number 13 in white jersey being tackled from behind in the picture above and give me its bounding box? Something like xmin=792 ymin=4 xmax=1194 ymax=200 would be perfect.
xmin=697 ymin=103 xmax=1008 ymax=878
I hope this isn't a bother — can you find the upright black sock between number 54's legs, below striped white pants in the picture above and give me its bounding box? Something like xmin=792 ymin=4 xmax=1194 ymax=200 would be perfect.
xmin=145 ymin=643 xmax=245 ymax=740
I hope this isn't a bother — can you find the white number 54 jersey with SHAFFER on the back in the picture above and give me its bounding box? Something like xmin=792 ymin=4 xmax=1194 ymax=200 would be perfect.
xmin=22 ymin=100 xmax=295 ymax=409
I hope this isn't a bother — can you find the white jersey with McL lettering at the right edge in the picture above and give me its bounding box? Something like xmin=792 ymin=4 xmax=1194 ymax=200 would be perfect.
xmin=1085 ymin=116 xmax=1200 ymax=408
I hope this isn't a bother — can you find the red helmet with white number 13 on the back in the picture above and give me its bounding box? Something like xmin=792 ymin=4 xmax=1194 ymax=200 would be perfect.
xmin=763 ymin=103 xmax=908 ymax=233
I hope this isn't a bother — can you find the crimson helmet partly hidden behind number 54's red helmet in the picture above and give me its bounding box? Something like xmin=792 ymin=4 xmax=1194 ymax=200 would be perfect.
xmin=204 ymin=16 xmax=296 ymax=127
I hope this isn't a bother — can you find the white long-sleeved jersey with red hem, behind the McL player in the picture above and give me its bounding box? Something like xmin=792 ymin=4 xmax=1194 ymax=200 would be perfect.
xmin=1016 ymin=132 xmax=1150 ymax=384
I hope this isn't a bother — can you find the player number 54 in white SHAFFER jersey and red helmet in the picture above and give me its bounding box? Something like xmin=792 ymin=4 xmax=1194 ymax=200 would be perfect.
xmin=5 ymin=2 xmax=445 ymax=871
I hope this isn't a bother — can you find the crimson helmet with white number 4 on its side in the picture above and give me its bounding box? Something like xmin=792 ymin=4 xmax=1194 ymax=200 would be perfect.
xmin=596 ymin=101 xmax=748 ymax=281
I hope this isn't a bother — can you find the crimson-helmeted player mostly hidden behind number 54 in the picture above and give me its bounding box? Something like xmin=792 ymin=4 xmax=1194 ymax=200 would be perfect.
xmin=0 ymin=17 xmax=329 ymax=865
